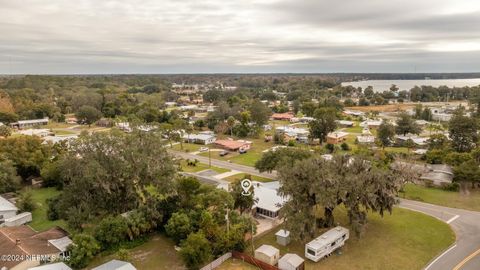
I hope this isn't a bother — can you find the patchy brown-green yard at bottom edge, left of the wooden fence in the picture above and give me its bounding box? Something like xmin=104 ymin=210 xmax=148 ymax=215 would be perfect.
xmin=88 ymin=234 xmax=186 ymax=270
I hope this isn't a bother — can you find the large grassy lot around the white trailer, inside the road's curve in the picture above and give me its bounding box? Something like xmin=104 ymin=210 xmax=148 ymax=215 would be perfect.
xmin=251 ymin=208 xmax=455 ymax=270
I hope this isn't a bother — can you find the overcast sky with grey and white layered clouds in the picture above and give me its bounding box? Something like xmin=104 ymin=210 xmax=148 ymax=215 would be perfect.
xmin=0 ymin=0 xmax=480 ymax=74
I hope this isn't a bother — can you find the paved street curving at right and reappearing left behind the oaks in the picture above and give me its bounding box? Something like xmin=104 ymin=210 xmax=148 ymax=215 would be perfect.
xmin=169 ymin=150 xmax=480 ymax=270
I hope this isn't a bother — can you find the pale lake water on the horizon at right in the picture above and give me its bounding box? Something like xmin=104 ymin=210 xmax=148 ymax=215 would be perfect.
xmin=342 ymin=78 xmax=480 ymax=92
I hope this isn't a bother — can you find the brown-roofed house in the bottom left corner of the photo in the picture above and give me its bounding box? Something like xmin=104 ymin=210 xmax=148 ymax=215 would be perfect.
xmin=0 ymin=225 xmax=71 ymax=269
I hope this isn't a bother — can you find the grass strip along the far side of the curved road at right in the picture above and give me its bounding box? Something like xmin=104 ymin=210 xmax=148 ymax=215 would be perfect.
xmin=401 ymin=184 xmax=480 ymax=211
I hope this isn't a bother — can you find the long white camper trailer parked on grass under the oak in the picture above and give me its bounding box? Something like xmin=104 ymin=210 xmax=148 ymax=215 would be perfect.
xmin=305 ymin=226 xmax=349 ymax=262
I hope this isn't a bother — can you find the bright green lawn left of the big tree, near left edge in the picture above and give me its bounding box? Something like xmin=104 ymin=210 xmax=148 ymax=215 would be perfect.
xmin=28 ymin=188 xmax=68 ymax=231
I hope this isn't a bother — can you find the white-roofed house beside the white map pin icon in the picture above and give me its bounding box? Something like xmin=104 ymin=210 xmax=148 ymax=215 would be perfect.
xmin=252 ymin=181 xmax=287 ymax=219
